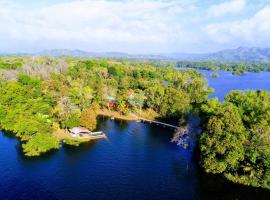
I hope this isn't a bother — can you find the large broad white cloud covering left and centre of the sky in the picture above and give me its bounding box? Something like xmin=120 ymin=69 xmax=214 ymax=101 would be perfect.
xmin=0 ymin=0 xmax=198 ymax=51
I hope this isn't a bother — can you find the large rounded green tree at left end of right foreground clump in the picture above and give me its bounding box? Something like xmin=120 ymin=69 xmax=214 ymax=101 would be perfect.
xmin=200 ymin=99 xmax=246 ymax=173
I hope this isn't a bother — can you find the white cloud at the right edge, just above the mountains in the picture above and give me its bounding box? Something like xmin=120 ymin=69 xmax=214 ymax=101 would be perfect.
xmin=205 ymin=6 xmax=270 ymax=46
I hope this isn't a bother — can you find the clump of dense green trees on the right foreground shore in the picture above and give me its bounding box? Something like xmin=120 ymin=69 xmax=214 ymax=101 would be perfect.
xmin=200 ymin=91 xmax=270 ymax=189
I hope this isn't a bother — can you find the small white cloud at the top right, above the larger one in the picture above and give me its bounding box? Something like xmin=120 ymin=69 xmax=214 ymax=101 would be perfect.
xmin=208 ymin=0 xmax=246 ymax=17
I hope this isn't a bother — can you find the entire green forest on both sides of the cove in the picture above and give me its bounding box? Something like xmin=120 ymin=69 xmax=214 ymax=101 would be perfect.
xmin=0 ymin=56 xmax=270 ymax=189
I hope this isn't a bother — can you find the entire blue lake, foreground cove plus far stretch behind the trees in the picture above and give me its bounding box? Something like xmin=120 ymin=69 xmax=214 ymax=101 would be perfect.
xmin=0 ymin=72 xmax=270 ymax=200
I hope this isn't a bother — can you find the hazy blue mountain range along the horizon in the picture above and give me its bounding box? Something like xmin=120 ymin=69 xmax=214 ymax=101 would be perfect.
xmin=3 ymin=47 xmax=270 ymax=62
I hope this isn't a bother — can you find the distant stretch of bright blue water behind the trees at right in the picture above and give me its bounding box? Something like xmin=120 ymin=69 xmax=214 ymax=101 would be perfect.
xmin=198 ymin=70 xmax=270 ymax=100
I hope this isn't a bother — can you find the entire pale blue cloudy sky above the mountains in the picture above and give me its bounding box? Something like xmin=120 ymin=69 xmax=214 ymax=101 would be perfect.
xmin=0 ymin=0 xmax=270 ymax=54
